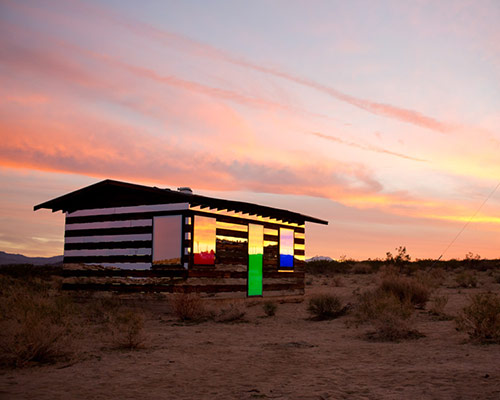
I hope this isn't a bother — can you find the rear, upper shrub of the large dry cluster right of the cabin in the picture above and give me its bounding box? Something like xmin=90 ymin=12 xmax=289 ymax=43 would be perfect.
xmin=380 ymin=275 xmax=430 ymax=308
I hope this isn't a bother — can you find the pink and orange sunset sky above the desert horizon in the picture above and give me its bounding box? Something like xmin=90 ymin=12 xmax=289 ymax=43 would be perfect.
xmin=0 ymin=0 xmax=500 ymax=259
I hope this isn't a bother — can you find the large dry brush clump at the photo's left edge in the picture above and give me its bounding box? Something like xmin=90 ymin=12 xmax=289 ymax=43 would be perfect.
xmin=0 ymin=276 xmax=76 ymax=367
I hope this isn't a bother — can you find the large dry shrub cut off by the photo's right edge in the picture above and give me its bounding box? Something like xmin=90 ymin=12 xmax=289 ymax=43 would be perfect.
xmin=457 ymin=293 xmax=500 ymax=343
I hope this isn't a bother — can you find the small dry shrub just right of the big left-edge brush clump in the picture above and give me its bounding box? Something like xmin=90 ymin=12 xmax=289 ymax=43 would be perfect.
xmin=110 ymin=309 xmax=145 ymax=350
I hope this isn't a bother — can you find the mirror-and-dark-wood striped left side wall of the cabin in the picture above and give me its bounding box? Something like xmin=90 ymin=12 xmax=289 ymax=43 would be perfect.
xmin=64 ymin=203 xmax=189 ymax=269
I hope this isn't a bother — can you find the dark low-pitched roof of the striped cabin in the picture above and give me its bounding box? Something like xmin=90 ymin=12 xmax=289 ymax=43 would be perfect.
xmin=33 ymin=179 xmax=328 ymax=225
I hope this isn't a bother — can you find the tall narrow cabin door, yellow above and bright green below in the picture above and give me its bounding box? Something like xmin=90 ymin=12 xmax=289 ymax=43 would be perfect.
xmin=248 ymin=224 xmax=264 ymax=296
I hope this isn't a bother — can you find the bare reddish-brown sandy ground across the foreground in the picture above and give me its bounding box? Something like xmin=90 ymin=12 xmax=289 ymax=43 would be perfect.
xmin=0 ymin=275 xmax=500 ymax=399
